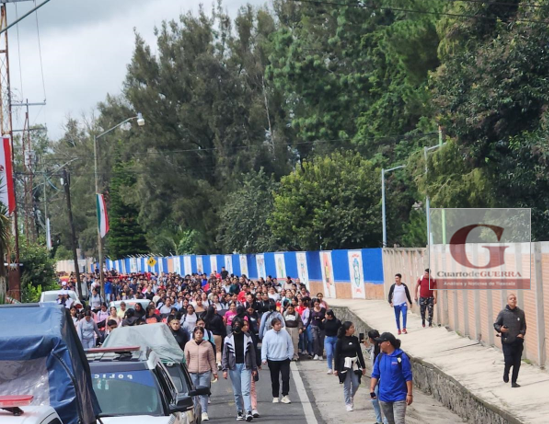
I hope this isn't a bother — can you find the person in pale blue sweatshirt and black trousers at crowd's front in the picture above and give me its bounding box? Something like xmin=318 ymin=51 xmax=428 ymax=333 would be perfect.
xmin=261 ymin=318 xmax=294 ymax=403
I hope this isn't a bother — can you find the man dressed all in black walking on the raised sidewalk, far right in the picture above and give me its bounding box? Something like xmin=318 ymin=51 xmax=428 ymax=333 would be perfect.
xmin=494 ymin=293 xmax=526 ymax=387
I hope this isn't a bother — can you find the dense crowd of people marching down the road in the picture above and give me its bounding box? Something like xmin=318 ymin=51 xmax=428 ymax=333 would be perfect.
xmin=55 ymin=268 xmax=411 ymax=424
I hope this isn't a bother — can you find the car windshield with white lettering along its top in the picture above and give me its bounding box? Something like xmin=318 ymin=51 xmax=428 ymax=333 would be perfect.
xmin=92 ymin=370 xmax=164 ymax=416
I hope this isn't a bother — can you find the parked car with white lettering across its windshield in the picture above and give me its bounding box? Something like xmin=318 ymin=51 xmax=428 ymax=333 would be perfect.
xmin=86 ymin=346 xmax=209 ymax=424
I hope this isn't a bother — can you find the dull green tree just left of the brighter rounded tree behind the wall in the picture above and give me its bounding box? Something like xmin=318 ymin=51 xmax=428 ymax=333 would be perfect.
xmin=218 ymin=169 xmax=278 ymax=253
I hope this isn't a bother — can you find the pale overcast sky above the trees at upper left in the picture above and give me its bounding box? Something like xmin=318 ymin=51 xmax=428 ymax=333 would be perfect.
xmin=8 ymin=0 xmax=267 ymax=139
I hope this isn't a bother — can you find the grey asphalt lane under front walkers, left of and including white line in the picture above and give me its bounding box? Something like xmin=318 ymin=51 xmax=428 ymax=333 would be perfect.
xmin=208 ymin=364 xmax=319 ymax=424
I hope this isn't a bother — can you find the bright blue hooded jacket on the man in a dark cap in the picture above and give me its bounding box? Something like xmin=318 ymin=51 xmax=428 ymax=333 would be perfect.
xmin=372 ymin=349 xmax=412 ymax=402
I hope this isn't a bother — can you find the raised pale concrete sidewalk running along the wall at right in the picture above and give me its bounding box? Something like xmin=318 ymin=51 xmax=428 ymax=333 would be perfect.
xmin=328 ymin=299 xmax=549 ymax=424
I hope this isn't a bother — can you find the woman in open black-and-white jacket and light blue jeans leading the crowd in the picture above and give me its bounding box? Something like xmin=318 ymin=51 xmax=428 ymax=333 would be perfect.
xmin=221 ymin=317 xmax=259 ymax=421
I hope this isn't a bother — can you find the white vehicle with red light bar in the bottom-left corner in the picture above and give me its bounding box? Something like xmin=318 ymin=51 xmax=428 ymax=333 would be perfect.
xmin=0 ymin=396 xmax=63 ymax=424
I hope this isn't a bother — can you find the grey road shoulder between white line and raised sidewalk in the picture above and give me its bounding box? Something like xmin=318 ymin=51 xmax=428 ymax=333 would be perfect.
xmin=297 ymin=360 xmax=464 ymax=424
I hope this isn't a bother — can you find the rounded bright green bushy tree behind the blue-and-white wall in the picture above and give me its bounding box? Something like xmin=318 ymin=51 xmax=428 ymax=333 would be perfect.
xmin=268 ymin=152 xmax=381 ymax=250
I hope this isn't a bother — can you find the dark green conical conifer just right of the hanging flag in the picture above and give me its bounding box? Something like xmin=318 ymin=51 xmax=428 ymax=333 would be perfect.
xmin=107 ymin=162 xmax=149 ymax=258
